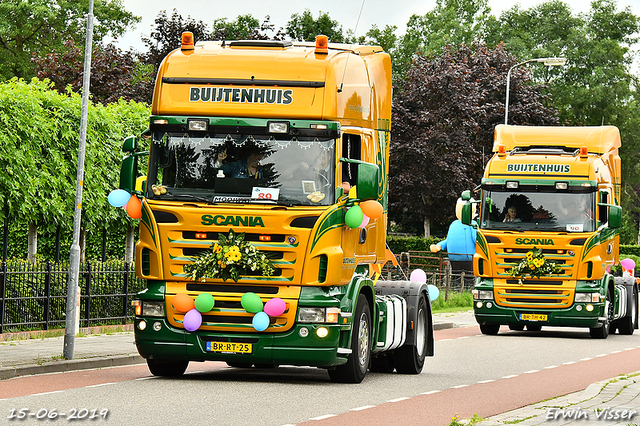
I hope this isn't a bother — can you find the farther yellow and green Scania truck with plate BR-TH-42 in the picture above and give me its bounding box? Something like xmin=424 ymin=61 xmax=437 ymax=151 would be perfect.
xmin=466 ymin=125 xmax=638 ymax=338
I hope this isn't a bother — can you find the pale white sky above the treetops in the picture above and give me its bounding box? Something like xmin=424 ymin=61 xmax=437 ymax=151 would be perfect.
xmin=106 ymin=0 xmax=640 ymax=51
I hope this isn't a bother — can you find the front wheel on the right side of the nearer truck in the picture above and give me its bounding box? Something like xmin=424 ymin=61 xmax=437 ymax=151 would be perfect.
xmin=329 ymin=294 xmax=371 ymax=383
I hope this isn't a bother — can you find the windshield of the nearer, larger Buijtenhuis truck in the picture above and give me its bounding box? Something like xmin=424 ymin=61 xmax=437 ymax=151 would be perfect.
xmin=148 ymin=133 xmax=336 ymax=205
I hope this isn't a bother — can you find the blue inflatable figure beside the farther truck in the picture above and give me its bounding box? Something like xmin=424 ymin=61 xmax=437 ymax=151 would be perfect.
xmin=430 ymin=198 xmax=477 ymax=273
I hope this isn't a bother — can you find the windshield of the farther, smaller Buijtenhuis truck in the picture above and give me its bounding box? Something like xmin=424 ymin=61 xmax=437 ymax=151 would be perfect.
xmin=480 ymin=189 xmax=595 ymax=232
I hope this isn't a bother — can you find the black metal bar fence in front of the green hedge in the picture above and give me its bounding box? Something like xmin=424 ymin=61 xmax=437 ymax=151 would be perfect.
xmin=0 ymin=261 xmax=144 ymax=333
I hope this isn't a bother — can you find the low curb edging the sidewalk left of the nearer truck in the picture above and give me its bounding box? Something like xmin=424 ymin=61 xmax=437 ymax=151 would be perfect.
xmin=0 ymin=355 xmax=146 ymax=380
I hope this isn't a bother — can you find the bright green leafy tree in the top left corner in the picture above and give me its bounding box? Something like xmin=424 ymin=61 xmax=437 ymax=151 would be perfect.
xmin=0 ymin=0 xmax=140 ymax=80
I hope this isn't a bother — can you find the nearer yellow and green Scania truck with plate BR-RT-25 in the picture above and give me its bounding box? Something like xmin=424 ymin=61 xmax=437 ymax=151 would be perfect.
xmin=120 ymin=33 xmax=433 ymax=383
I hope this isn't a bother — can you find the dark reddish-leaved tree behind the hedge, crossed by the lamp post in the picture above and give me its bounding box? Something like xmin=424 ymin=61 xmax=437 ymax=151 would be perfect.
xmin=32 ymin=39 xmax=155 ymax=104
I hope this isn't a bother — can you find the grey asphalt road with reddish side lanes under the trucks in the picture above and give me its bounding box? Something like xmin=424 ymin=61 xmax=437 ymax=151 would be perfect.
xmin=0 ymin=326 xmax=640 ymax=426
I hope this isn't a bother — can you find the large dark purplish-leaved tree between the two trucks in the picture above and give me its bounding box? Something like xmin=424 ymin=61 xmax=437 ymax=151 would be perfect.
xmin=389 ymin=43 xmax=557 ymax=236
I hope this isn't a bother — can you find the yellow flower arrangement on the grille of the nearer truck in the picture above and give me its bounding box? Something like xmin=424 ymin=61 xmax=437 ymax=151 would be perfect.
xmin=183 ymin=230 xmax=275 ymax=282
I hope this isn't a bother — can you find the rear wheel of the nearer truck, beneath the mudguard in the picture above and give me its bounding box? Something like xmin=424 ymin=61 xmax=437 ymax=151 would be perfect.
xmin=394 ymin=296 xmax=429 ymax=374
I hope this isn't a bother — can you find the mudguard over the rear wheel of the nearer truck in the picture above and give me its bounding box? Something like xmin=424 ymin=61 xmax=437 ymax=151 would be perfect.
xmin=375 ymin=280 xmax=434 ymax=356
